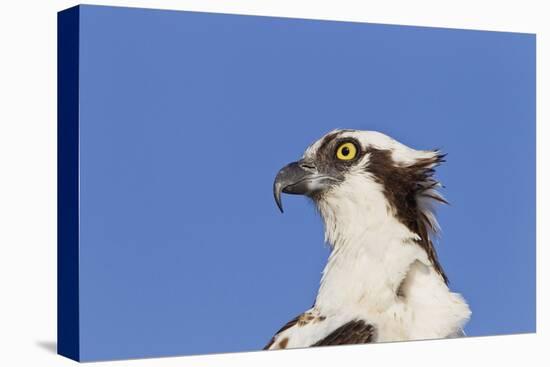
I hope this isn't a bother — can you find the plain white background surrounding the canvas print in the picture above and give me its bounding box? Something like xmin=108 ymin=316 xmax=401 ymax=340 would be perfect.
xmin=0 ymin=0 xmax=550 ymax=366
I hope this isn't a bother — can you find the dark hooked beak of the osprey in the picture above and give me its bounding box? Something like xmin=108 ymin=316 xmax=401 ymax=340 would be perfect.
xmin=273 ymin=160 xmax=337 ymax=213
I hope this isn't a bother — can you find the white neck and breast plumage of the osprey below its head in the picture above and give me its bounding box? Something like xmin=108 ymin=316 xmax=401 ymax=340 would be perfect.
xmin=314 ymin=179 xmax=470 ymax=341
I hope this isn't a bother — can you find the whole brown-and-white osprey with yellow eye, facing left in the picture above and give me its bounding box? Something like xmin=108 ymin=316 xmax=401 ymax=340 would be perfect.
xmin=264 ymin=130 xmax=471 ymax=349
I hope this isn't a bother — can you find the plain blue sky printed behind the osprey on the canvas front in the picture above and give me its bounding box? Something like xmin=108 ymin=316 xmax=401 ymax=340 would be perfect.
xmin=76 ymin=6 xmax=535 ymax=360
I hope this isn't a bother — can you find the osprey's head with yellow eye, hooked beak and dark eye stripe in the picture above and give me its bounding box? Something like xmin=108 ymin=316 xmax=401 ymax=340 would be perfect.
xmin=273 ymin=130 xmax=444 ymax=212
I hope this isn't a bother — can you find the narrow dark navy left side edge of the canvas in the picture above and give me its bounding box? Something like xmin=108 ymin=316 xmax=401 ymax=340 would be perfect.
xmin=57 ymin=7 xmax=80 ymax=360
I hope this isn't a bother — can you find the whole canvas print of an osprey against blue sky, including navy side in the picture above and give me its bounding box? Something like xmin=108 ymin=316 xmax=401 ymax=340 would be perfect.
xmin=58 ymin=5 xmax=536 ymax=361
